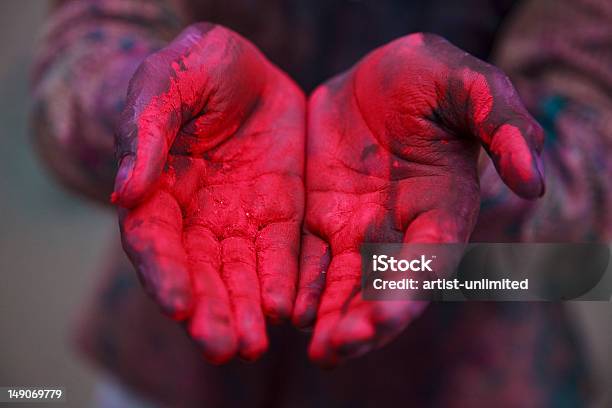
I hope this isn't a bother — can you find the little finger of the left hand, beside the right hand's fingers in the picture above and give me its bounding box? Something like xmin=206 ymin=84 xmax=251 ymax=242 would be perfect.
xmin=255 ymin=222 xmax=300 ymax=322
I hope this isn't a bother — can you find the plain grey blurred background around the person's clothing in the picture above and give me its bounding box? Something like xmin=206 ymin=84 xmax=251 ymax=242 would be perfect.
xmin=0 ymin=0 xmax=612 ymax=407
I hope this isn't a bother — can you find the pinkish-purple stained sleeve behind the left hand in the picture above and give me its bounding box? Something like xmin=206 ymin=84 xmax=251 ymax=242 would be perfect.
xmin=31 ymin=0 xmax=181 ymax=202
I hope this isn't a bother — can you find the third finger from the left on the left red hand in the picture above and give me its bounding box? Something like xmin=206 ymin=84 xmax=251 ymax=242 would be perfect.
xmin=221 ymin=238 xmax=268 ymax=360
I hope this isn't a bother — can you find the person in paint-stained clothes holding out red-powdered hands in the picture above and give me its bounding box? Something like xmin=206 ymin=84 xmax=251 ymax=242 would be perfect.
xmin=30 ymin=0 xmax=612 ymax=407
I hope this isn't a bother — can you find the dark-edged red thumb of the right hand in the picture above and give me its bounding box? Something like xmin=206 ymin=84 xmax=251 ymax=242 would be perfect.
xmin=416 ymin=35 xmax=545 ymax=198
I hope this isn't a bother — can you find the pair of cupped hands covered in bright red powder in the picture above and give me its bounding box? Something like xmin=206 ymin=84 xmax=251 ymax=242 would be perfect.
xmin=112 ymin=24 xmax=544 ymax=366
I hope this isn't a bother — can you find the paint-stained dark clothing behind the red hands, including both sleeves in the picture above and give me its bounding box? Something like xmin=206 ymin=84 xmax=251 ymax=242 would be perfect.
xmin=33 ymin=0 xmax=612 ymax=407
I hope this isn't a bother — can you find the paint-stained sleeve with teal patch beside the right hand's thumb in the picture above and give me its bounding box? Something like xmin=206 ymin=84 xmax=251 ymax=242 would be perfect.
xmin=474 ymin=0 xmax=612 ymax=241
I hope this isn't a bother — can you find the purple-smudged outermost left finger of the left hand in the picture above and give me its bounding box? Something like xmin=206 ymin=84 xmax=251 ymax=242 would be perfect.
xmin=120 ymin=191 xmax=193 ymax=320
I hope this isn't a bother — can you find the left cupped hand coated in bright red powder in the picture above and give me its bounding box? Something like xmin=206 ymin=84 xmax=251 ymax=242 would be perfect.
xmin=112 ymin=24 xmax=305 ymax=363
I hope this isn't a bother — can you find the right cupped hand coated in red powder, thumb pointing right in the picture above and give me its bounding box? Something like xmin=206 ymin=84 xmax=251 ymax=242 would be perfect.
xmin=293 ymin=34 xmax=544 ymax=365
